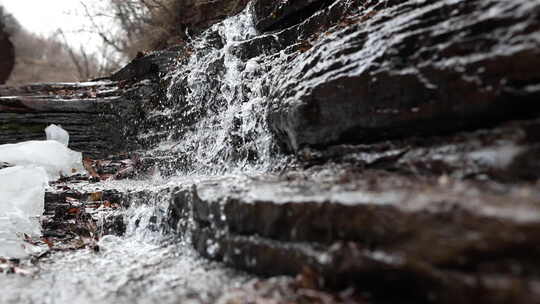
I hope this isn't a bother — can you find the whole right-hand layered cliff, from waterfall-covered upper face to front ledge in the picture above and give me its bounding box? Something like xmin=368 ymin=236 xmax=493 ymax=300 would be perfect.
xmin=150 ymin=0 xmax=540 ymax=303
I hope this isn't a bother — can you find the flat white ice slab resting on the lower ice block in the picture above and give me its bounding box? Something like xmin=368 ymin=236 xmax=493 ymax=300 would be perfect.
xmin=0 ymin=140 xmax=84 ymax=180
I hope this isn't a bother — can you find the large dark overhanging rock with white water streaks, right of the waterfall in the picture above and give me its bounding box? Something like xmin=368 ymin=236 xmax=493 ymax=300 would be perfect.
xmin=268 ymin=0 xmax=540 ymax=150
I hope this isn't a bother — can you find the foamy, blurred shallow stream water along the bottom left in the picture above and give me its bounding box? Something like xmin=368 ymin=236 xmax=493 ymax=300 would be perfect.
xmin=0 ymin=236 xmax=250 ymax=303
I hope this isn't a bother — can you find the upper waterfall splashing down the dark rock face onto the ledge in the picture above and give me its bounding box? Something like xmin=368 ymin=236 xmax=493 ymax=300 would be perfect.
xmin=145 ymin=8 xmax=286 ymax=175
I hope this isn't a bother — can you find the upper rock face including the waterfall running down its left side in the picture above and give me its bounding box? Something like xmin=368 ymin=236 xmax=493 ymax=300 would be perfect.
xmin=131 ymin=0 xmax=540 ymax=171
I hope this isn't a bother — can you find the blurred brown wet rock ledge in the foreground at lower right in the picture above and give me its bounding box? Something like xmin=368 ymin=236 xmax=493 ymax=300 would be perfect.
xmin=163 ymin=171 xmax=540 ymax=303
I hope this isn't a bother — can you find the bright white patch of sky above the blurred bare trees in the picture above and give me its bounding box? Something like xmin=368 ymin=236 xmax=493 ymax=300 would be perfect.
xmin=0 ymin=0 xmax=104 ymax=49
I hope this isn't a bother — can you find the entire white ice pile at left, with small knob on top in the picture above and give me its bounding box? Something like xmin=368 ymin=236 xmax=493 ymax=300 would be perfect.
xmin=0 ymin=125 xmax=84 ymax=258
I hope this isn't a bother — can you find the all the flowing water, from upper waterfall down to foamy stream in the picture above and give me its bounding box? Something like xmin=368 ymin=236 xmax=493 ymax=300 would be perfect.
xmin=0 ymin=5 xmax=294 ymax=303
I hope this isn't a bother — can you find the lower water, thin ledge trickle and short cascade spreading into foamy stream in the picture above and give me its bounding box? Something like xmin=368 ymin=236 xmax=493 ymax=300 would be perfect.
xmin=0 ymin=178 xmax=258 ymax=303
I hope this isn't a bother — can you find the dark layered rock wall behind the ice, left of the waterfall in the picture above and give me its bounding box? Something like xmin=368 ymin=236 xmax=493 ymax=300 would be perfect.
xmin=0 ymin=79 xmax=158 ymax=157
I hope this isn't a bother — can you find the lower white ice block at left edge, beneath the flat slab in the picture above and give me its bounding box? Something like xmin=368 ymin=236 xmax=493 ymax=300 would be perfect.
xmin=0 ymin=166 xmax=48 ymax=258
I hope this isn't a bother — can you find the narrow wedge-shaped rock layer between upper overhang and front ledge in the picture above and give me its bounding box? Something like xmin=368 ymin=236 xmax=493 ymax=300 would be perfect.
xmin=297 ymin=119 xmax=540 ymax=182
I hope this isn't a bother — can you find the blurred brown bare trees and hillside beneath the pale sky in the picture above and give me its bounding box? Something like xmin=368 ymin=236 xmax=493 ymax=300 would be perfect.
xmin=0 ymin=0 xmax=184 ymax=85
